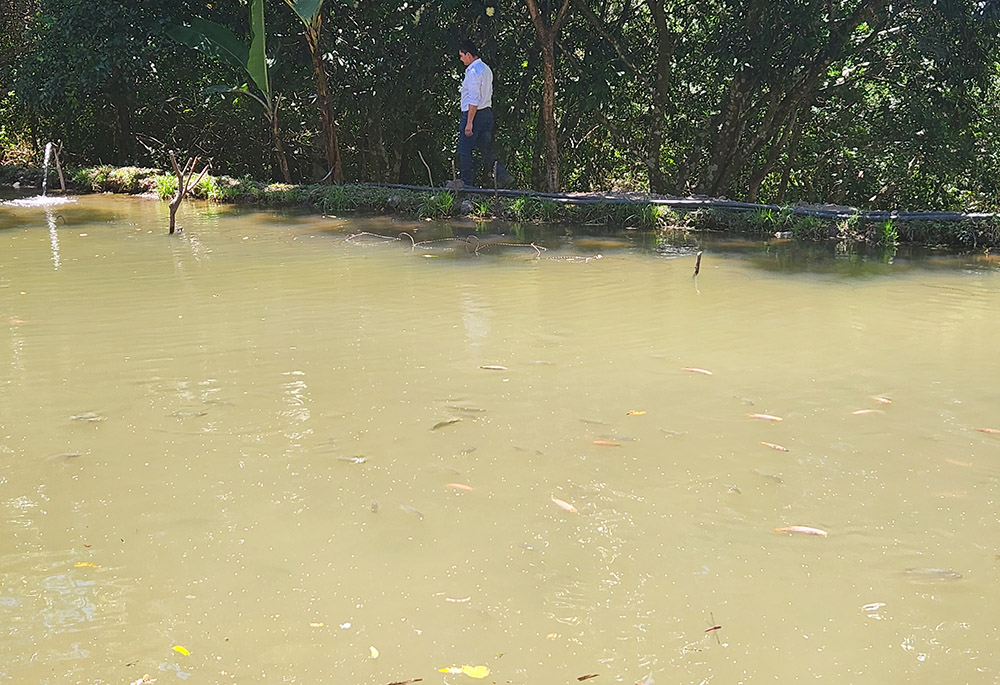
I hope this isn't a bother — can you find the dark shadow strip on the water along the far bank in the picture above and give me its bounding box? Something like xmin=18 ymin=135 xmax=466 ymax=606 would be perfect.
xmin=0 ymin=188 xmax=1000 ymax=278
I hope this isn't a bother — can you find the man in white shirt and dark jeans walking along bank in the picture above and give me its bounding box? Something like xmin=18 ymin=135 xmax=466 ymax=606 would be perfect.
xmin=458 ymin=40 xmax=511 ymax=186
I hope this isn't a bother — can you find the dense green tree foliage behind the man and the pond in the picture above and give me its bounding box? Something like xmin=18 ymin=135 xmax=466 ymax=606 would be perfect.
xmin=0 ymin=0 xmax=1000 ymax=208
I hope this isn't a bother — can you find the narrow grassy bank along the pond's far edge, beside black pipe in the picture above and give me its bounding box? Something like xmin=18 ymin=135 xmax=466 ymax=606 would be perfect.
xmin=0 ymin=165 xmax=1000 ymax=249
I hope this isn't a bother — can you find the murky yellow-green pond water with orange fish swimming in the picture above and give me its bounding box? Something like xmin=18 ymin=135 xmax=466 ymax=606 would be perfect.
xmin=0 ymin=197 xmax=1000 ymax=685
